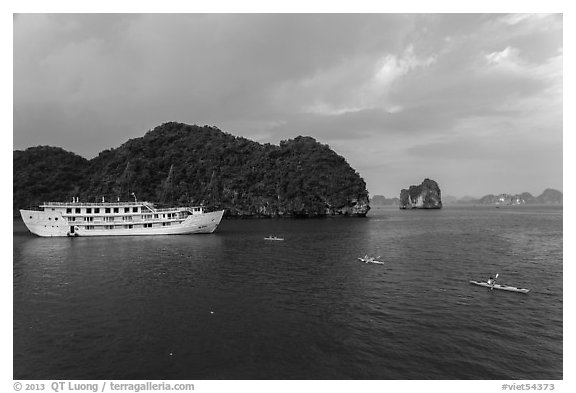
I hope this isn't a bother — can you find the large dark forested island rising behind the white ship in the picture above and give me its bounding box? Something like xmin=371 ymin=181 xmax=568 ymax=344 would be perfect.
xmin=13 ymin=122 xmax=370 ymax=217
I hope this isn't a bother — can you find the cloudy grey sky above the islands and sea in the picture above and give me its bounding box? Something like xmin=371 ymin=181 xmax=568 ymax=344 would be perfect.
xmin=13 ymin=14 xmax=563 ymax=197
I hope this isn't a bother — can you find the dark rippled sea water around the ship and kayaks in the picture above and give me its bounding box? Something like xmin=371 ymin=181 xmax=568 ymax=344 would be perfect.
xmin=14 ymin=207 xmax=563 ymax=380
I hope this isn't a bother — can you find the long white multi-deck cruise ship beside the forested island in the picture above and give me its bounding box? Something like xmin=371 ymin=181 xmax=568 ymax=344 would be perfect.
xmin=20 ymin=198 xmax=224 ymax=237
